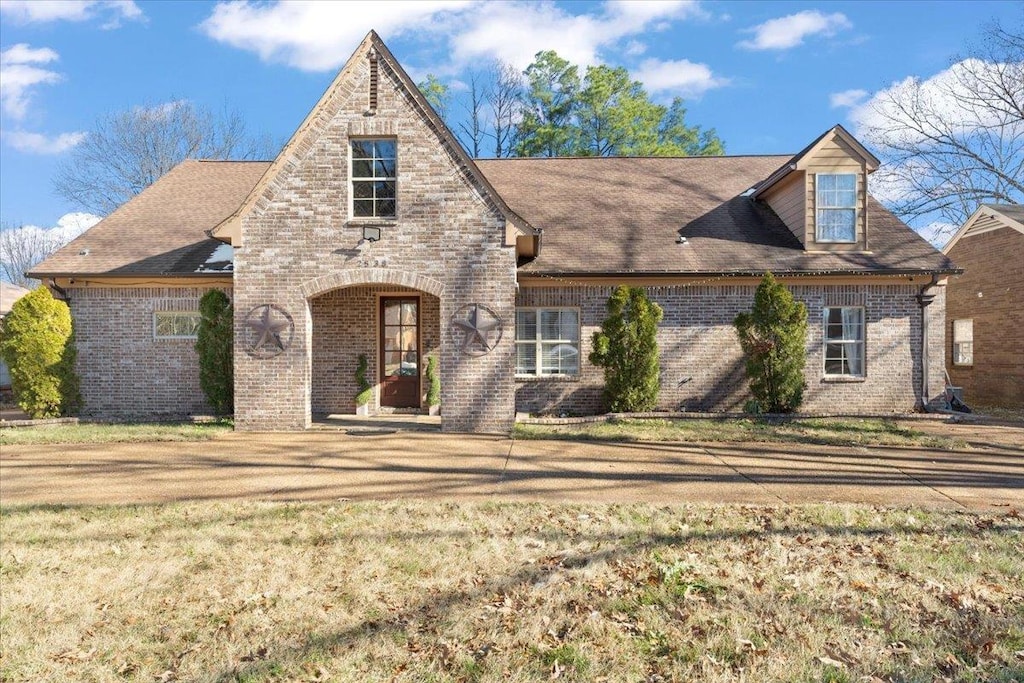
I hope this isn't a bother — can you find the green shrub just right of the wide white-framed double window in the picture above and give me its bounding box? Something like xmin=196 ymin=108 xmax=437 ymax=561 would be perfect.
xmin=590 ymin=286 xmax=663 ymax=413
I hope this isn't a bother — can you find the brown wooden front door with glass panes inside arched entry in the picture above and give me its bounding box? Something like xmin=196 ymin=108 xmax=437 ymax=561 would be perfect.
xmin=380 ymin=297 xmax=420 ymax=408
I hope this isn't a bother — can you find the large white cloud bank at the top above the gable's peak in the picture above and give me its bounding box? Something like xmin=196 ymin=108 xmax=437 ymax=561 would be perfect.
xmin=200 ymin=0 xmax=703 ymax=75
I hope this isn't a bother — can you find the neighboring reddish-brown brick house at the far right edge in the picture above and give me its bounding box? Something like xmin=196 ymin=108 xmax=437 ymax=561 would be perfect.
xmin=942 ymin=204 xmax=1024 ymax=409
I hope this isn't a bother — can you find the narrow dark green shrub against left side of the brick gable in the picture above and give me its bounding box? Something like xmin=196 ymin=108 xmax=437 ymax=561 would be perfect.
xmin=196 ymin=290 xmax=234 ymax=415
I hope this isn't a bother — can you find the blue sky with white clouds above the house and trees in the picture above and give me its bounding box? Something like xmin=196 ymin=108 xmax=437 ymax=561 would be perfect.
xmin=0 ymin=0 xmax=1024 ymax=232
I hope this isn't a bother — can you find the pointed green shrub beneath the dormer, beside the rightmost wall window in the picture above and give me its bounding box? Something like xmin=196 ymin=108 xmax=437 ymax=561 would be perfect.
xmin=733 ymin=272 xmax=807 ymax=413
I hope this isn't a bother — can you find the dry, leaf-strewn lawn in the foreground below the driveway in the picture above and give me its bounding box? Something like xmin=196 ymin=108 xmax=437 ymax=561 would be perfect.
xmin=0 ymin=501 xmax=1024 ymax=683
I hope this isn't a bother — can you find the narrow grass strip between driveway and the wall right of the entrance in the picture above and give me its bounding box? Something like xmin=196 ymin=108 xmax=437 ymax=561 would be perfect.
xmin=515 ymin=418 xmax=967 ymax=451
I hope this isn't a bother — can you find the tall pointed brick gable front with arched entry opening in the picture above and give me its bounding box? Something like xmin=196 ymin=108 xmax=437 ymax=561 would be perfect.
xmin=234 ymin=52 xmax=516 ymax=431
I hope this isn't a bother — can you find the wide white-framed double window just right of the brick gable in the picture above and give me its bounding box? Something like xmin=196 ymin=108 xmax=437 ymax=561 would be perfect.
xmin=515 ymin=308 xmax=580 ymax=377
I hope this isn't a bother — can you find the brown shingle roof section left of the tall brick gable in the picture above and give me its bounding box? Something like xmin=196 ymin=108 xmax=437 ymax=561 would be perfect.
xmin=30 ymin=159 xmax=269 ymax=278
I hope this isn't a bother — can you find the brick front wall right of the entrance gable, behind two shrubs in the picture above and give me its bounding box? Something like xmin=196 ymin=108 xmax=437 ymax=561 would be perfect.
xmin=516 ymin=285 xmax=944 ymax=415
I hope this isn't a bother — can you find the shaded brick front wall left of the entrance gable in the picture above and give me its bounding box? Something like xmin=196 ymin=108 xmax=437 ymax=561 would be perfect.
xmin=68 ymin=287 xmax=231 ymax=420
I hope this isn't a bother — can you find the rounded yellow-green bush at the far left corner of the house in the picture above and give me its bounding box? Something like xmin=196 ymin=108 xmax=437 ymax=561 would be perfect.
xmin=0 ymin=287 xmax=82 ymax=419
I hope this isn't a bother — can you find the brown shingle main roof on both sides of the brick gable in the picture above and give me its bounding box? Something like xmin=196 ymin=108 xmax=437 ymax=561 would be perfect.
xmin=32 ymin=156 xmax=954 ymax=276
